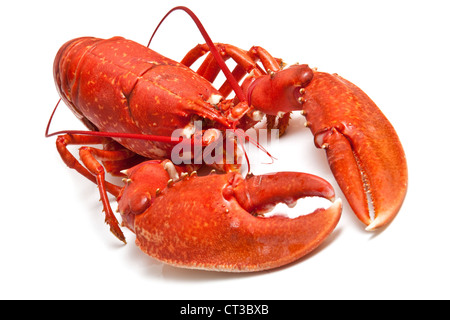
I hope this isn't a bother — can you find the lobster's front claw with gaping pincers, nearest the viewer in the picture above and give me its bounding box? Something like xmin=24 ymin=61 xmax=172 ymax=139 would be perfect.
xmin=119 ymin=163 xmax=342 ymax=272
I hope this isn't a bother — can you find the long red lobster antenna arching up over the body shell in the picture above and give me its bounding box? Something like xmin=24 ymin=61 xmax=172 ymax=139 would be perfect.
xmin=147 ymin=6 xmax=246 ymax=102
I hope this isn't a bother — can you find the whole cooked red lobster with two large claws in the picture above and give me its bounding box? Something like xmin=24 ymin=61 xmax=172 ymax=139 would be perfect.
xmin=46 ymin=7 xmax=407 ymax=271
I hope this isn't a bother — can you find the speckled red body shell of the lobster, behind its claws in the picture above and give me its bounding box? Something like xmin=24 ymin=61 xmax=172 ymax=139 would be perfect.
xmin=54 ymin=37 xmax=229 ymax=159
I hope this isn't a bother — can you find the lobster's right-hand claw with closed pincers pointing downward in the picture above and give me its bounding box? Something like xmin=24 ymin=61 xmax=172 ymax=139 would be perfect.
xmin=303 ymin=72 xmax=408 ymax=230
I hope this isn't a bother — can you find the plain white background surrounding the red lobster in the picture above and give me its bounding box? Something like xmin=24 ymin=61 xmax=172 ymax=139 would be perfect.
xmin=0 ymin=0 xmax=450 ymax=299
